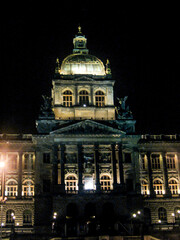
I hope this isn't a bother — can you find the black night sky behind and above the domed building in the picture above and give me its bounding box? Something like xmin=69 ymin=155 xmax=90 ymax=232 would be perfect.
xmin=0 ymin=1 xmax=180 ymax=134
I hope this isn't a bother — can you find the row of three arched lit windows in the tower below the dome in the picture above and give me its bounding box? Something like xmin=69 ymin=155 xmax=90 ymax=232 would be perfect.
xmin=62 ymin=90 xmax=105 ymax=107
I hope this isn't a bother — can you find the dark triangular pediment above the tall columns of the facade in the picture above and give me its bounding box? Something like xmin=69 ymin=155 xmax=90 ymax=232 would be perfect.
xmin=50 ymin=120 xmax=125 ymax=135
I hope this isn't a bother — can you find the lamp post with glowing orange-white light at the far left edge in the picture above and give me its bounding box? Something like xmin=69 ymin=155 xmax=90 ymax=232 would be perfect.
xmin=0 ymin=161 xmax=7 ymax=239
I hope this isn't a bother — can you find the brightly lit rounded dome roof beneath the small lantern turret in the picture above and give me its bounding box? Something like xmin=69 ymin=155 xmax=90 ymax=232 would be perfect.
xmin=60 ymin=53 xmax=106 ymax=76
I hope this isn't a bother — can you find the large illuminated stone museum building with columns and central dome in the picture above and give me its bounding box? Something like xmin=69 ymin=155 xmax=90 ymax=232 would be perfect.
xmin=0 ymin=27 xmax=180 ymax=237
